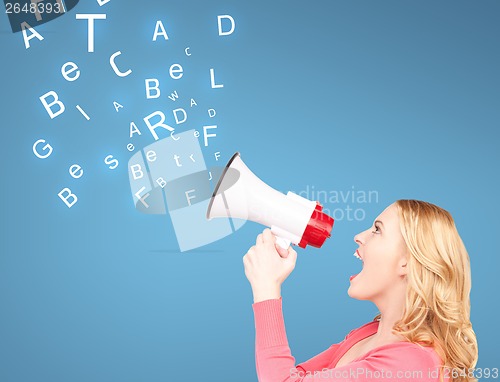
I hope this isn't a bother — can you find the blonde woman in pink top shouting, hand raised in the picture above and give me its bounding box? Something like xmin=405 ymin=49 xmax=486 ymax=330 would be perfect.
xmin=243 ymin=200 xmax=478 ymax=382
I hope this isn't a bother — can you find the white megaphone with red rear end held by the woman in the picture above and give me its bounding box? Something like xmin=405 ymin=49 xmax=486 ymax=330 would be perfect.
xmin=207 ymin=152 xmax=334 ymax=248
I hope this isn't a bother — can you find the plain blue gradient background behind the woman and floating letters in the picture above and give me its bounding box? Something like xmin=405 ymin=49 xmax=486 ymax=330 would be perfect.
xmin=0 ymin=0 xmax=500 ymax=382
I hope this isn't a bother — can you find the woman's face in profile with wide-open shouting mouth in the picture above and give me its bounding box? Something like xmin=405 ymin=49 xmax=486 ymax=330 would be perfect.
xmin=347 ymin=204 xmax=407 ymax=302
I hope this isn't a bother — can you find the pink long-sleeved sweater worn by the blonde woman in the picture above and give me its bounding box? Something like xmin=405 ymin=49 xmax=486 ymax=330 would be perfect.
xmin=252 ymin=298 xmax=447 ymax=382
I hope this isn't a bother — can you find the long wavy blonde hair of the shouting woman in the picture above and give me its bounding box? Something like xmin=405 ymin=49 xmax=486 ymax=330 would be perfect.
xmin=375 ymin=200 xmax=478 ymax=382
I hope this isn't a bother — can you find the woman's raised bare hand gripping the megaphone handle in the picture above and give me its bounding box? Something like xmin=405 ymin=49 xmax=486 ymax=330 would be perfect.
xmin=243 ymin=228 xmax=297 ymax=303
